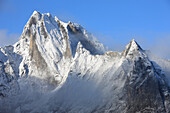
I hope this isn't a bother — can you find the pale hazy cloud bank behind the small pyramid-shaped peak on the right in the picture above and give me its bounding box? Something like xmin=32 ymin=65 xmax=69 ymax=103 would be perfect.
xmin=95 ymin=33 xmax=170 ymax=59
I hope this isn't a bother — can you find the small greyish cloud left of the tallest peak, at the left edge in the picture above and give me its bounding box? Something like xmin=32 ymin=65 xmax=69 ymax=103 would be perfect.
xmin=0 ymin=30 xmax=20 ymax=47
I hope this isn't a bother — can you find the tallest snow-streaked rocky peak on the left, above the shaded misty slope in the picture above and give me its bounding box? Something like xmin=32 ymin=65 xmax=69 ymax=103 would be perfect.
xmin=14 ymin=11 xmax=104 ymax=83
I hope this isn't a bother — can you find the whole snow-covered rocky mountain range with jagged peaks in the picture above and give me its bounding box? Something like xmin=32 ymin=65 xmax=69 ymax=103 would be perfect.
xmin=0 ymin=11 xmax=170 ymax=113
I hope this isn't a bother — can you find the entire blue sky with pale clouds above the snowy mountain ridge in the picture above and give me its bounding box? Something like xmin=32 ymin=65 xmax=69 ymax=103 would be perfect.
xmin=0 ymin=0 xmax=170 ymax=58
